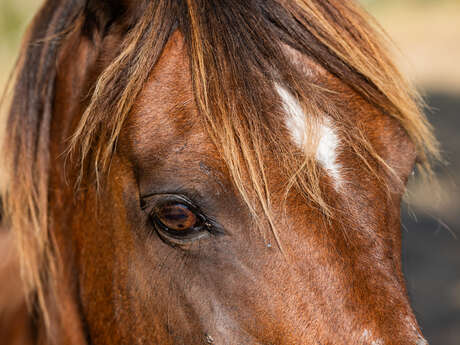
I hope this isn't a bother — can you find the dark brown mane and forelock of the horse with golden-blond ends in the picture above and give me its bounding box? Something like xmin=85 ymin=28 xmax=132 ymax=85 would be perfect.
xmin=2 ymin=0 xmax=439 ymax=334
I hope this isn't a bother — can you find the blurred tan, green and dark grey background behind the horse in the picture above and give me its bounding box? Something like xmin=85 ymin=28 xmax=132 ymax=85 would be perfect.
xmin=0 ymin=0 xmax=460 ymax=345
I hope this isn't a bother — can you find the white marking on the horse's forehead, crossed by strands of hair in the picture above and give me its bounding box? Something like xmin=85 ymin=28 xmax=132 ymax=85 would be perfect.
xmin=275 ymin=84 xmax=342 ymax=187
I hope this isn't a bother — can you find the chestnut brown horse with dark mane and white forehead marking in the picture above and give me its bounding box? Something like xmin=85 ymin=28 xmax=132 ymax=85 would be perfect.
xmin=1 ymin=0 xmax=439 ymax=345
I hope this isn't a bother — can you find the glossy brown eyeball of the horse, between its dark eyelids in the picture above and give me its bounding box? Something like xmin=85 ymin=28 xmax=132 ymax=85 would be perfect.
xmin=156 ymin=203 xmax=198 ymax=231
